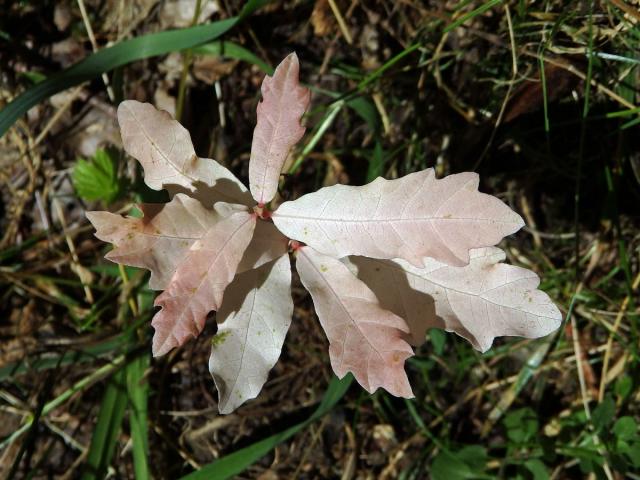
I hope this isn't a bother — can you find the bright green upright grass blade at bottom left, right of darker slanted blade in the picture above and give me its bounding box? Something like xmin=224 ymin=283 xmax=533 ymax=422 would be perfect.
xmin=126 ymin=355 xmax=151 ymax=480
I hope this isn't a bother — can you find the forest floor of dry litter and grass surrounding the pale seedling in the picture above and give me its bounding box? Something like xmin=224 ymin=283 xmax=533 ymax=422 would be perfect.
xmin=0 ymin=0 xmax=640 ymax=480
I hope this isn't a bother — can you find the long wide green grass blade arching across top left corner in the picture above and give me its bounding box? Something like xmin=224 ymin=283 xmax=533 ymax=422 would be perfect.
xmin=0 ymin=0 xmax=267 ymax=136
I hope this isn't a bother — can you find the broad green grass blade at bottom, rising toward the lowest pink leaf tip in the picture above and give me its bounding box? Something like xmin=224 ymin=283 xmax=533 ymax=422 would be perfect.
xmin=182 ymin=374 xmax=353 ymax=480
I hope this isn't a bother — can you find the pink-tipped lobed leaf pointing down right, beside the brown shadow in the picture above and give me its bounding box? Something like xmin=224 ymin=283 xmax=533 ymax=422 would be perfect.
xmin=296 ymin=247 xmax=413 ymax=398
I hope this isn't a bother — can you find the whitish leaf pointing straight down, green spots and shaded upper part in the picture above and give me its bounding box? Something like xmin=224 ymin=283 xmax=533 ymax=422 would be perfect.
xmin=209 ymin=254 xmax=293 ymax=413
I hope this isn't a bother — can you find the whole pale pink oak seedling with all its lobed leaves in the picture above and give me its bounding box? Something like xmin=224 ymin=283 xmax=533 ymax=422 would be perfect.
xmin=87 ymin=54 xmax=561 ymax=413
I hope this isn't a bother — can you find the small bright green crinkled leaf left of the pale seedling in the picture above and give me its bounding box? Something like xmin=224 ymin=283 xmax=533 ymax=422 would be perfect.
xmin=71 ymin=150 xmax=123 ymax=204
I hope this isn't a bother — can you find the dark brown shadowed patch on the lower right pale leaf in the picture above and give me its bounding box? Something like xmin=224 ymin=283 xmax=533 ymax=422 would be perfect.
xmin=342 ymin=256 xmax=445 ymax=346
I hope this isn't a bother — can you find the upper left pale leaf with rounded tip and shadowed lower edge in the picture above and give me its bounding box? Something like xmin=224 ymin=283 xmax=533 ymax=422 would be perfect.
xmin=118 ymin=100 xmax=254 ymax=206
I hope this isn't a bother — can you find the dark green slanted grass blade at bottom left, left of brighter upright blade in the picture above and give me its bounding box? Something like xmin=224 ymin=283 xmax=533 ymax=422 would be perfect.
xmin=81 ymin=370 xmax=127 ymax=480
